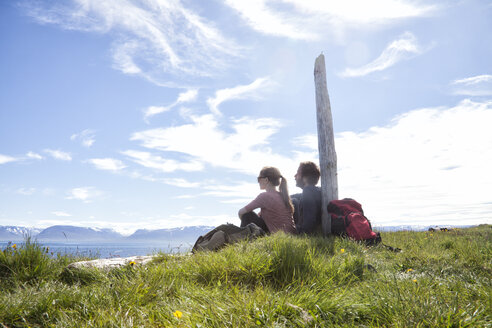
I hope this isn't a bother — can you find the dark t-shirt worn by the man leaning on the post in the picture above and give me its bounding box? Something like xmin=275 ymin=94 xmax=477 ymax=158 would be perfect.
xmin=291 ymin=186 xmax=321 ymax=234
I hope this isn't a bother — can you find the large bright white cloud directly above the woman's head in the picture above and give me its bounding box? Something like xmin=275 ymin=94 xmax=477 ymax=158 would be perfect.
xmin=131 ymin=114 xmax=295 ymax=175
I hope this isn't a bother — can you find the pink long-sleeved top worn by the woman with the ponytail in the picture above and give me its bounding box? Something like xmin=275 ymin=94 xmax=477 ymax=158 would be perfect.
xmin=244 ymin=191 xmax=296 ymax=233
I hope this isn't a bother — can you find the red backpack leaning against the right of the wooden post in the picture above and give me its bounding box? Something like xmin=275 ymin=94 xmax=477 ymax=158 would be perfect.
xmin=328 ymin=198 xmax=381 ymax=245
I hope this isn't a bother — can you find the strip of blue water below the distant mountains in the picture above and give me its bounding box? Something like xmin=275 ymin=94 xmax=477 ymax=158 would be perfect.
xmin=0 ymin=242 xmax=193 ymax=258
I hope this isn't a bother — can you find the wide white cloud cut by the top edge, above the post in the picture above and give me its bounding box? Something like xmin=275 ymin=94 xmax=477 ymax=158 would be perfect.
xmin=225 ymin=0 xmax=436 ymax=40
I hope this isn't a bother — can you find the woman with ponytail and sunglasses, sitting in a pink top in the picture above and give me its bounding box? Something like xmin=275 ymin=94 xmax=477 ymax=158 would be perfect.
xmin=238 ymin=166 xmax=296 ymax=233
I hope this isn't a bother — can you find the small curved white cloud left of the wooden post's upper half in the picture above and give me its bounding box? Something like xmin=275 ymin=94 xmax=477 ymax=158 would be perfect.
xmin=207 ymin=77 xmax=273 ymax=115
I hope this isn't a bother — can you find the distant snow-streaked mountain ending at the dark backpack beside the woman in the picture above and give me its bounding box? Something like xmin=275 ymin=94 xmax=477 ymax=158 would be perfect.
xmin=125 ymin=226 xmax=214 ymax=243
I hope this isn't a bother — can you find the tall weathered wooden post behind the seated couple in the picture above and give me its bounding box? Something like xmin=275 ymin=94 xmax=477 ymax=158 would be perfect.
xmin=314 ymin=54 xmax=338 ymax=236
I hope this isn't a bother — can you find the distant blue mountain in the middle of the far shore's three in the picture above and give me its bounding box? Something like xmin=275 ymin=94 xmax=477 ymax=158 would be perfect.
xmin=36 ymin=225 xmax=123 ymax=242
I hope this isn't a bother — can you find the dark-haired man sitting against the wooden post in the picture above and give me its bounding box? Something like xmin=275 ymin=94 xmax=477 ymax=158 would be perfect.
xmin=291 ymin=162 xmax=321 ymax=234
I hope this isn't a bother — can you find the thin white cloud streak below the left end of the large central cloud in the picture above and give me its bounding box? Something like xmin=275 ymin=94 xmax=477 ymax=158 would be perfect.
xmin=121 ymin=150 xmax=203 ymax=172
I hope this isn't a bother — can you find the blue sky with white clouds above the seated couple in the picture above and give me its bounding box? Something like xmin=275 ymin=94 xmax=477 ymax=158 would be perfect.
xmin=0 ymin=0 xmax=492 ymax=234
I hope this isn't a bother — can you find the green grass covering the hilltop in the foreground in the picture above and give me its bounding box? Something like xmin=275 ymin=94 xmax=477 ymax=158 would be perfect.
xmin=0 ymin=225 xmax=492 ymax=327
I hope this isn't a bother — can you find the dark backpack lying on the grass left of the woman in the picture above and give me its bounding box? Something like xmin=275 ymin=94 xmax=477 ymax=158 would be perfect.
xmin=192 ymin=223 xmax=265 ymax=253
